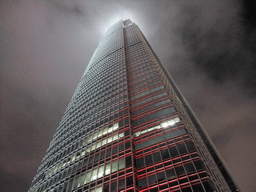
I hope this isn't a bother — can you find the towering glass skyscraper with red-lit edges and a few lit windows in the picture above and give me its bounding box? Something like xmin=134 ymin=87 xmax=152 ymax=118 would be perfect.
xmin=29 ymin=20 xmax=238 ymax=192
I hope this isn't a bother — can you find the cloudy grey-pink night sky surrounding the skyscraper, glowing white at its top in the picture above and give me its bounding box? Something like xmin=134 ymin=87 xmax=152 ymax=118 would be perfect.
xmin=0 ymin=0 xmax=256 ymax=192
